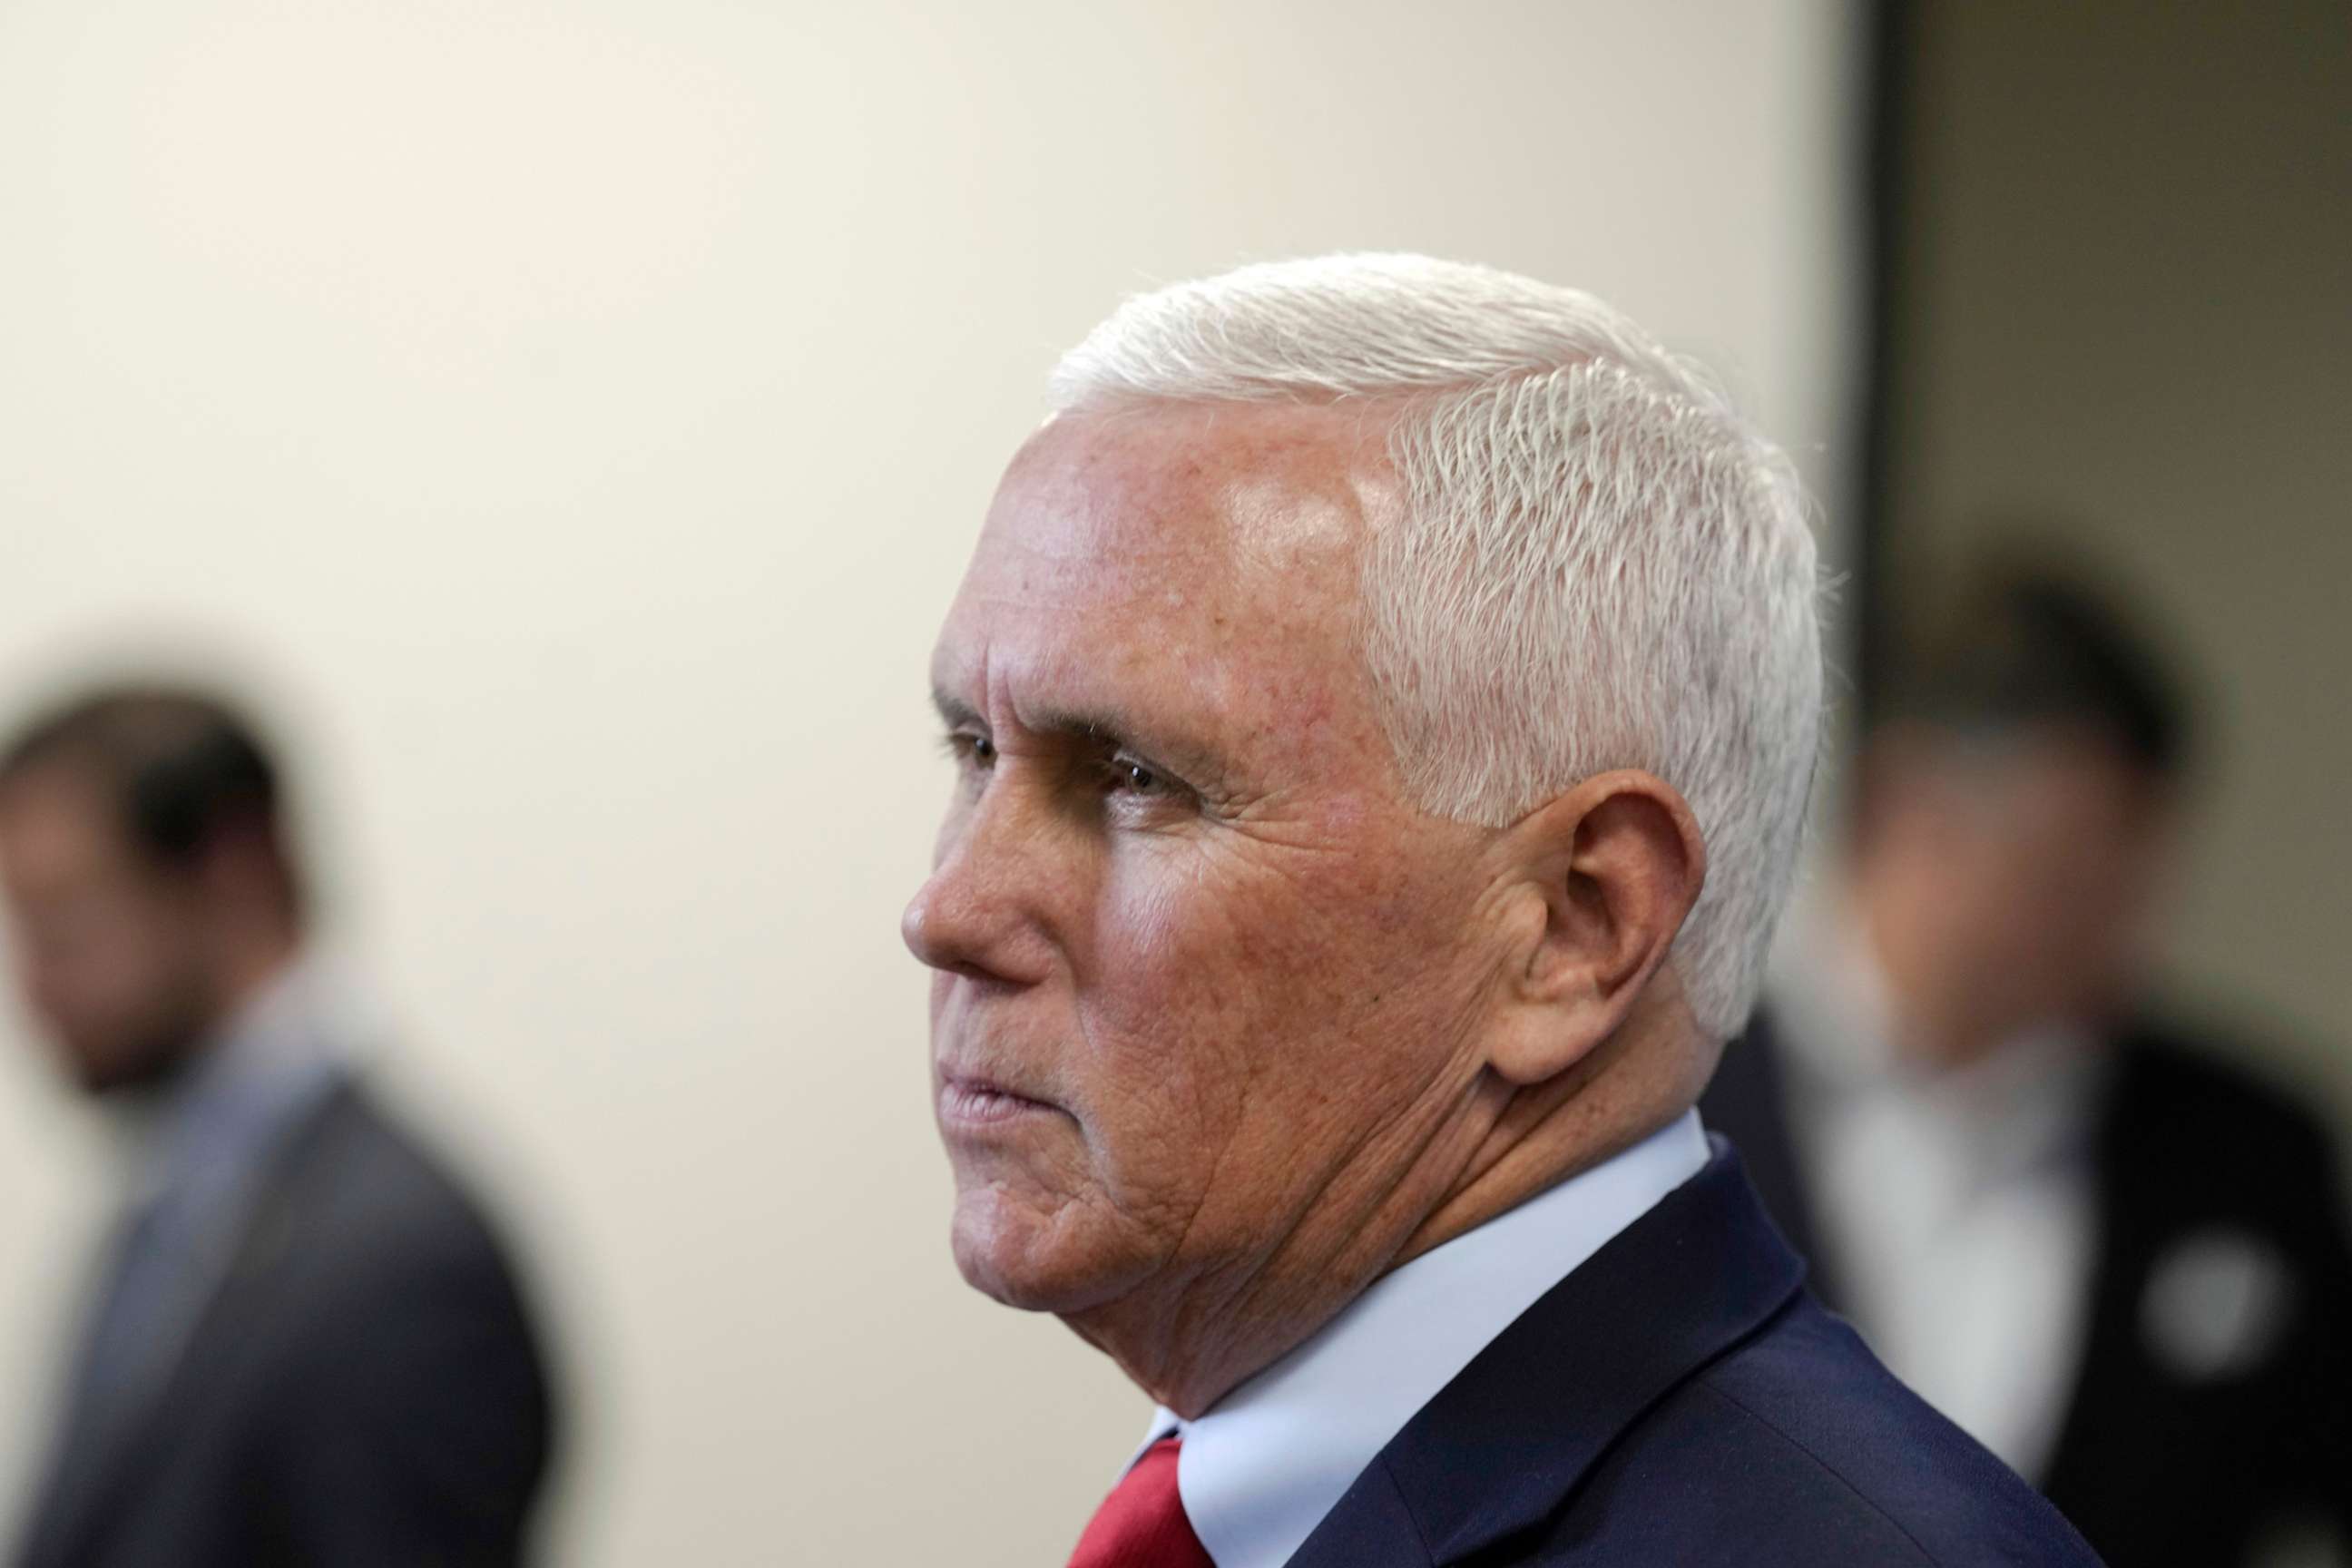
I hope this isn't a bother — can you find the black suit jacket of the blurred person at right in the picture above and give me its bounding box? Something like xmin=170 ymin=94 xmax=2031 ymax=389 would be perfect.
xmin=1700 ymin=1008 xmax=2352 ymax=1568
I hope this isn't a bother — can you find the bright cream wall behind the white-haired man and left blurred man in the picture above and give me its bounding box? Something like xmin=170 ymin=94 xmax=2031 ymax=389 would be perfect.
xmin=0 ymin=0 xmax=1847 ymax=1568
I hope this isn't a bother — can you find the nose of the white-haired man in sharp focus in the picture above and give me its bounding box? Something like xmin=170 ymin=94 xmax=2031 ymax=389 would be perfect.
xmin=898 ymin=789 xmax=1056 ymax=985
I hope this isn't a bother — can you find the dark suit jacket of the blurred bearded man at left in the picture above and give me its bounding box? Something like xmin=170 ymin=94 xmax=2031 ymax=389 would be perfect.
xmin=16 ymin=1011 xmax=553 ymax=1568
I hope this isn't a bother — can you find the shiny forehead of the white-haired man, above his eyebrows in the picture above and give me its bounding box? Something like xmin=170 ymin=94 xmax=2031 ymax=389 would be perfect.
xmin=934 ymin=405 xmax=1395 ymax=752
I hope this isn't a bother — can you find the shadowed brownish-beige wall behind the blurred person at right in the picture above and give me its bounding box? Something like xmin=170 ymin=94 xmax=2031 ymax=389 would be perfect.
xmin=1894 ymin=0 xmax=2352 ymax=1126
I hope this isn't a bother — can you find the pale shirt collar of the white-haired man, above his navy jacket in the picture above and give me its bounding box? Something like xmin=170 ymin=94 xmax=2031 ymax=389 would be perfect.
xmin=1143 ymin=1112 xmax=1708 ymax=1568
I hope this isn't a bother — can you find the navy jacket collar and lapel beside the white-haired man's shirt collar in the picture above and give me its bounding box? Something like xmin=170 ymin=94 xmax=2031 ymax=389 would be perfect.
xmin=1291 ymin=1142 xmax=1804 ymax=1568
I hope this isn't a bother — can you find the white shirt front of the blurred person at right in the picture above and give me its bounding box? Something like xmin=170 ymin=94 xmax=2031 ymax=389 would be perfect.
xmin=1773 ymin=910 xmax=2101 ymax=1479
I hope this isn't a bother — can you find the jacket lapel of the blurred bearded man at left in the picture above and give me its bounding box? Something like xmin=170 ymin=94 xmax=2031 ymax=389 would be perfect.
xmin=24 ymin=1083 xmax=355 ymax=1568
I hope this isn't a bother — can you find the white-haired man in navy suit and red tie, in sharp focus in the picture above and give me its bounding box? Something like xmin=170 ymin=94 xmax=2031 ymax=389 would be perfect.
xmin=906 ymin=259 xmax=2095 ymax=1568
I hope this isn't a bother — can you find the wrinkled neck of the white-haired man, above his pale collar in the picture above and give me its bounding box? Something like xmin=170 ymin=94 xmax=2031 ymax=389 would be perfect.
xmin=1063 ymin=1005 xmax=1715 ymax=1420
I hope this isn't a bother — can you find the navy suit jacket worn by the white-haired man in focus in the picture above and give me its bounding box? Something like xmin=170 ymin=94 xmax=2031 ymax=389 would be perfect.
xmin=1291 ymin=1140 xmax=2098 ymax=1568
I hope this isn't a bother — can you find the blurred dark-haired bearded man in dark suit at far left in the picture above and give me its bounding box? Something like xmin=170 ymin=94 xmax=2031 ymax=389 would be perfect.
xmin=0 ymin=686 xmax=551 ymax=1568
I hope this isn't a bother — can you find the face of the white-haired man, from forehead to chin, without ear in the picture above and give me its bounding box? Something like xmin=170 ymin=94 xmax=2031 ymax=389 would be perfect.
xmin=906 ymin=407 xmax=1496 ymax=1314
